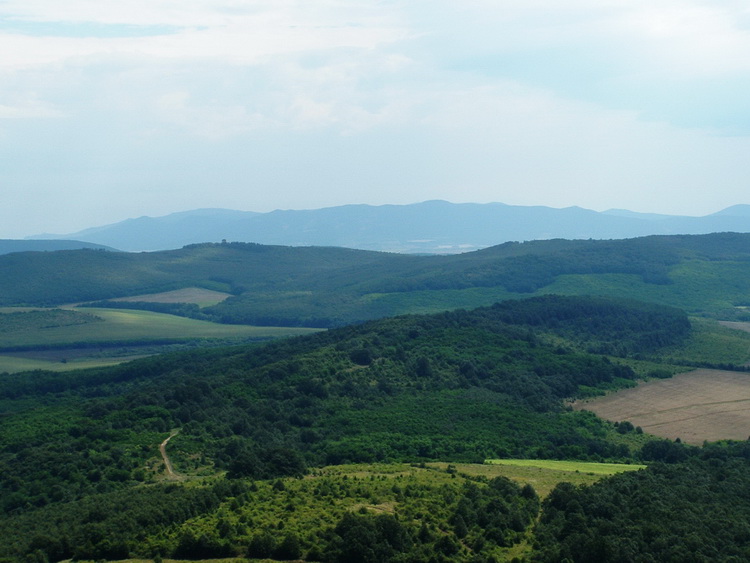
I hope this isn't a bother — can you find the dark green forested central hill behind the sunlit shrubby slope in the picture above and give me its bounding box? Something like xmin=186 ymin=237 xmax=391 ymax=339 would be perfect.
xmin=0 ymin=296 xmax=690 ymax=560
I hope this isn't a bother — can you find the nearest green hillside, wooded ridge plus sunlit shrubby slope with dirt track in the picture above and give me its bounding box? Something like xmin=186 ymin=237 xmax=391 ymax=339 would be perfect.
xmin=0 ymin=297 xmax=716 ymax=561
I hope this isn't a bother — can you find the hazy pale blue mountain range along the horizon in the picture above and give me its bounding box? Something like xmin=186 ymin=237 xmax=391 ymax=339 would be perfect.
xmin=28 ymin=201 xmax=750 ymax=254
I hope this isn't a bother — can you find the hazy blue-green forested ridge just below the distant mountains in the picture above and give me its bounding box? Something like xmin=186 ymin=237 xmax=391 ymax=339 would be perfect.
xmin=0 ymin=233 xmax=750 ymax=327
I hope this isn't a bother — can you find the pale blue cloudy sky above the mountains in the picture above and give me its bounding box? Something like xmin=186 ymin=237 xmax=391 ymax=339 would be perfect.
xmin=0 ymin=0 xmax=750 ymax=238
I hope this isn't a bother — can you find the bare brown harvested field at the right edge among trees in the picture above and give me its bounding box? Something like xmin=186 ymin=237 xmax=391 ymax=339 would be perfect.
xmin=573 ymin=369 xmax=750 ymax=445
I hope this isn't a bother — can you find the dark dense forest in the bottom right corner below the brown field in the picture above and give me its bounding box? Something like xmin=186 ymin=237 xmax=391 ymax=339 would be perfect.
xmin=534 ymin=442 xmax=750 ymax=563
